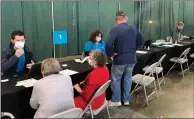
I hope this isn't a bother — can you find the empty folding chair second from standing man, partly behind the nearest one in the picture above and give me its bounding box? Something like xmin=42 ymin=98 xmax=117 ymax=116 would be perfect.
xmin=143 ymin=54 xmax=166 ymax=89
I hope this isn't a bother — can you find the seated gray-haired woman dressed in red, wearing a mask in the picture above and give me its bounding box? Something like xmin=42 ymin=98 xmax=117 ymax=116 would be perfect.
xmin=74 ymin=50 xmax=109 ymax=110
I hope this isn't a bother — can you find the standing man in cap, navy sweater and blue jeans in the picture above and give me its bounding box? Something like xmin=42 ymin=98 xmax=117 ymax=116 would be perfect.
xmin=106 ymin=11 xmax=144 ymax=106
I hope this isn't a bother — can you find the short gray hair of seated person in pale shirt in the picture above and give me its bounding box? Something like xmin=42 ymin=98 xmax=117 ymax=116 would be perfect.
xmin=41 ymin=58 xmax=61 ymax=76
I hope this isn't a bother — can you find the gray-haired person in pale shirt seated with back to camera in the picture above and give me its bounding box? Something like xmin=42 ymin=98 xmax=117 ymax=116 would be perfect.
xmin=30 ymin=58 xmax=75 ymax=118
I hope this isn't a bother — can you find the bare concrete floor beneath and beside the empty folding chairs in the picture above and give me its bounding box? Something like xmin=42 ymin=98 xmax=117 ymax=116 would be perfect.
xmin=96 ymin=70 xmax=194 ymax=118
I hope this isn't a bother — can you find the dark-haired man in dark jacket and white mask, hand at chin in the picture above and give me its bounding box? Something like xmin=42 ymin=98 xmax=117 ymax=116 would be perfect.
xmin=1 ymin=30 xmax=34 ymax=75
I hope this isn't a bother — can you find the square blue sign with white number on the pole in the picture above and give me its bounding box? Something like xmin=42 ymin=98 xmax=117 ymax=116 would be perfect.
xmin=53 ymin=31 xmax=67 ymax=44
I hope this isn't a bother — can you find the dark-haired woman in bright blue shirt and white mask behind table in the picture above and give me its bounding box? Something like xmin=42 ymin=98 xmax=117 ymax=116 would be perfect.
xmin=84 ymin=30 xmax=105 ymax=56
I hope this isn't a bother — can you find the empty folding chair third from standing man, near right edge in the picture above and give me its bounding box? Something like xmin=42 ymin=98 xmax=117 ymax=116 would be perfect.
xmin=167 ymin=48 xmax=191 ymax=78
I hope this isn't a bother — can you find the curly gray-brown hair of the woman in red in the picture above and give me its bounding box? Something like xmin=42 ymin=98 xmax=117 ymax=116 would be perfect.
xmin=90 ymin=50 xmax=107 ymax=67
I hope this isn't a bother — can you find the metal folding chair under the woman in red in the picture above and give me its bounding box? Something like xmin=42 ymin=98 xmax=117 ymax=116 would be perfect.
xmin=82 ymin=80 xmax=111 ymax=119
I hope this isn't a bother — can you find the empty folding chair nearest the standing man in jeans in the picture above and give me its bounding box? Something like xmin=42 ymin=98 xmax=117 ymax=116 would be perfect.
xmin=131 ymin=62 xmax=159 ymax=105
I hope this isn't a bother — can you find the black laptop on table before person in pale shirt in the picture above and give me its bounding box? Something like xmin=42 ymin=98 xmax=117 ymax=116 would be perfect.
xmin=28 ymin=63 xmax=42 ymax=78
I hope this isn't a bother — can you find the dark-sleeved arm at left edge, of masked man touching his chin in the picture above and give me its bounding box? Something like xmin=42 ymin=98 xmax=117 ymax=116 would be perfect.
xmin=1 ymin=51 xmax=18 ymax=73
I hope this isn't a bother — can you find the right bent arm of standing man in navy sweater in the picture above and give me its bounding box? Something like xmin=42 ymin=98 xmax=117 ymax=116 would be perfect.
xmin=136 ymin=29 xmax=144 ymax=49
